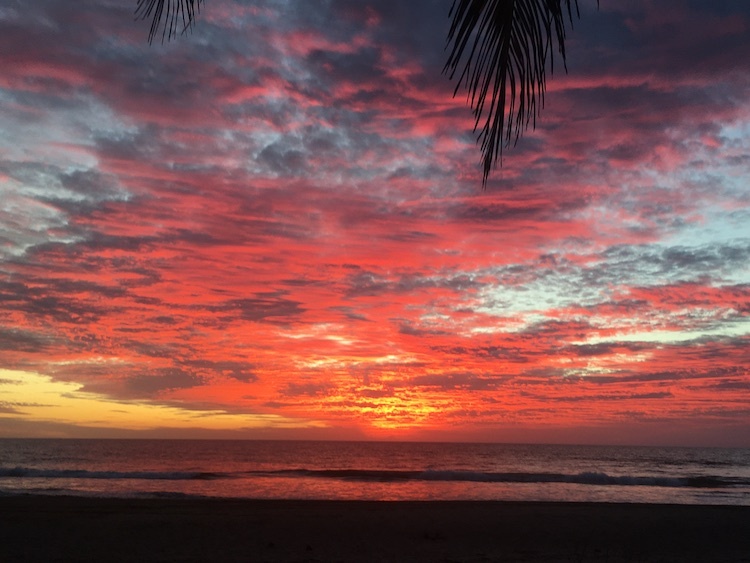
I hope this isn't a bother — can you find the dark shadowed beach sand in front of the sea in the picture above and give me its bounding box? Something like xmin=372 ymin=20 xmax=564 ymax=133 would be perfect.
xmin=0 ymin=496 xmax=750 ymax=562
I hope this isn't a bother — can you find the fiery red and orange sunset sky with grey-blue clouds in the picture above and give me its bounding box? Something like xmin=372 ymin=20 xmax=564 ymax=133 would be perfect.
xmin=0 ymin=0 xmax=750 ymax=446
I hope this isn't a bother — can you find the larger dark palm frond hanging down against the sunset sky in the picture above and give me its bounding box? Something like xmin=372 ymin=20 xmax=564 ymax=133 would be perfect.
xmin=443 ymin=0 xmax=578 ymax=187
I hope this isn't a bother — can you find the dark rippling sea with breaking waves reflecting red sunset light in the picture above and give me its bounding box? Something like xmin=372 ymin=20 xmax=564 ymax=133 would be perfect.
xmin=0 ymin=439 xmax=750 ymax=505
